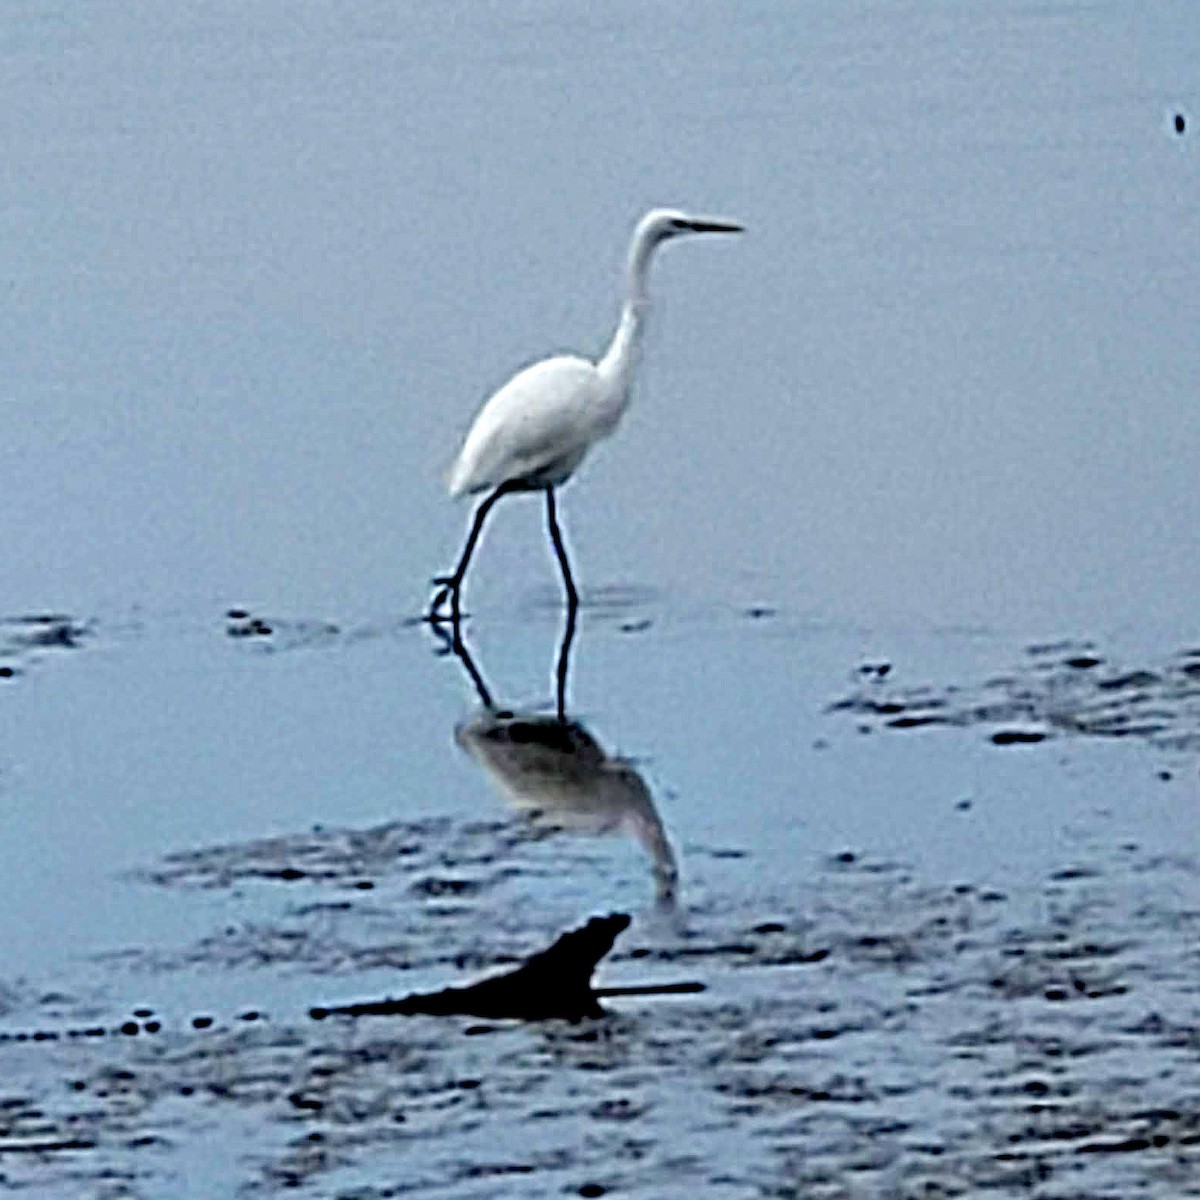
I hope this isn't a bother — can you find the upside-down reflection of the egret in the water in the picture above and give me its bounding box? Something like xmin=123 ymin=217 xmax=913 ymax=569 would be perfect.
xmin=433 ymin=605 xmax=679 ymax=911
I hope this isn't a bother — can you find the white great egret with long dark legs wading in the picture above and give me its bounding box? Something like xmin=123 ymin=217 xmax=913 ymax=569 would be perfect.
xmin=430 ymin=209 xmax=742 ymax=622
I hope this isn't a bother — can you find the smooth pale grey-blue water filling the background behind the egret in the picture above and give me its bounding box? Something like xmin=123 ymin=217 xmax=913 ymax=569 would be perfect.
xmin=0 ymin=2 xmax=1200 ymax=632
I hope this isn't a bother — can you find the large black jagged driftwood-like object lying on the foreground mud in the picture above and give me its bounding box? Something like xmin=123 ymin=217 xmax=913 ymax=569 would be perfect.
xmin=308 ymin=912 xmax=704 ymax=1021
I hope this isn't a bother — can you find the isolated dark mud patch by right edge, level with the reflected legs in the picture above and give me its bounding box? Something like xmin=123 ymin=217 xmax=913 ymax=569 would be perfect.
xmin=830 ymin=642 xmax=1200 ymax=751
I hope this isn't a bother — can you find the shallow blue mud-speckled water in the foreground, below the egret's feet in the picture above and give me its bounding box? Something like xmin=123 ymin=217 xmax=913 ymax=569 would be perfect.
xmin=0 ymin=609 xmax=1200 ymax=1196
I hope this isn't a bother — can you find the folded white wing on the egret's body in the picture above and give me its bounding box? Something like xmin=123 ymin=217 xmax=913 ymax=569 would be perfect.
xmin=449 ymin=356 xmax=602 ymax=496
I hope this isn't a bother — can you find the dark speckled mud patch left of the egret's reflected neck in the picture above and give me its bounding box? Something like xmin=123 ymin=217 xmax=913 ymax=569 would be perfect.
xmin=115 ymin=818 xmax=598 ymax=974
